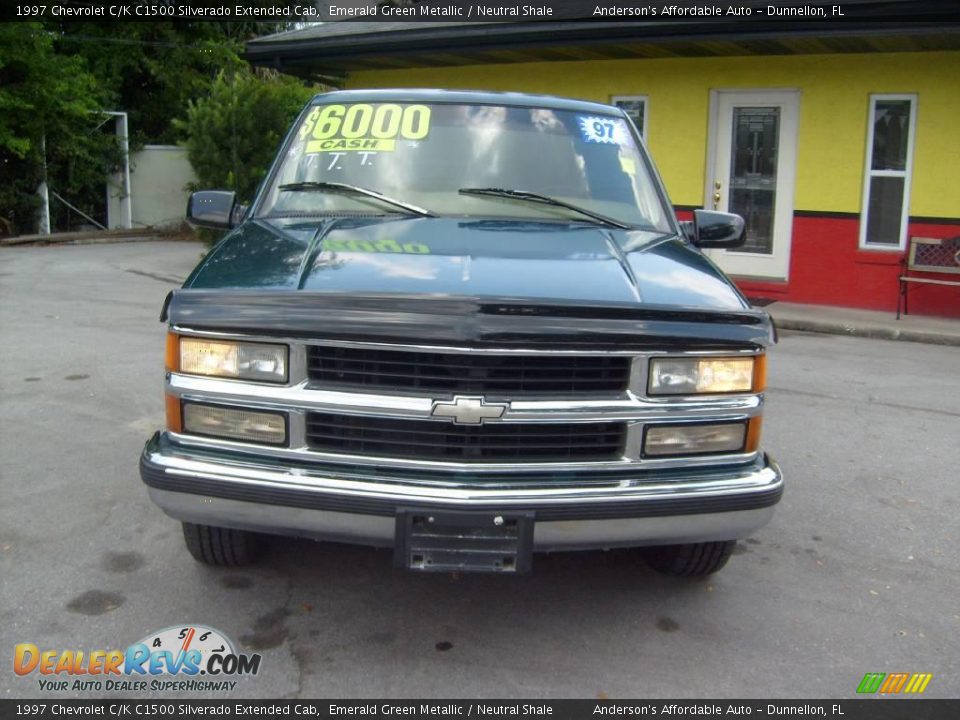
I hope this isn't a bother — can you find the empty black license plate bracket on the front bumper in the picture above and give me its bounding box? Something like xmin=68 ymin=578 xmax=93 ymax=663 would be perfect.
xmin=394 ymin=508 xmax=534 ymax=574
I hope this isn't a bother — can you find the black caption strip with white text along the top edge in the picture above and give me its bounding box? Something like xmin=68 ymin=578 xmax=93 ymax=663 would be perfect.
xmin=0 ymin=0 xmax=960 ymax=24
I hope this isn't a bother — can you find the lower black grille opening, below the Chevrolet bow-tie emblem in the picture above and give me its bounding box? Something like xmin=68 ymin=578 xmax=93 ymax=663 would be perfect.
xmin=307 ymin=412 xmax=626 ymax=462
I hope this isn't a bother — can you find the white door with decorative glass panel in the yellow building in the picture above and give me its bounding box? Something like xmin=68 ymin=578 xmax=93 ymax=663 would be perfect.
xmin=704 ymin=90 xmax=800 ymax=280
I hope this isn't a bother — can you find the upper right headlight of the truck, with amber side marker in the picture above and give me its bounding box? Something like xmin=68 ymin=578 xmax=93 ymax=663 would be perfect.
xmin=648 ymin=355 xmax=765 ymax=395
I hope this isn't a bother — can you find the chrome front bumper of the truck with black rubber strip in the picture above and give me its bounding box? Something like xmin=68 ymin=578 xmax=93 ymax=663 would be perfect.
xmin=140 ymin=433 xmax=783 ymax=550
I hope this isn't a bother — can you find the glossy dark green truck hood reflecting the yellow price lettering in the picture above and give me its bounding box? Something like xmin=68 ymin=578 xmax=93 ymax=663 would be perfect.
xmin=184 ymin=217 xmax=749 ymax=311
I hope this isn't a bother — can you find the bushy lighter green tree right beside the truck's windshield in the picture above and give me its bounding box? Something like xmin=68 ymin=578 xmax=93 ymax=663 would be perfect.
xmin=176 ymin=69 xmax=315 ymax=202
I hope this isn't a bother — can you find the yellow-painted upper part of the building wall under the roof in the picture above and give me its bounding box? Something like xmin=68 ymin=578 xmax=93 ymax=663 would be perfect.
xmin=347 ymin=52 xmax=960 ymax=218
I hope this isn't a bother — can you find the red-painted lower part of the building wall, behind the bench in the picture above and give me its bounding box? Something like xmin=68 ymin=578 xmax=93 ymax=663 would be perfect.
xmin=677 ymin=210 xmax=960 ymax=318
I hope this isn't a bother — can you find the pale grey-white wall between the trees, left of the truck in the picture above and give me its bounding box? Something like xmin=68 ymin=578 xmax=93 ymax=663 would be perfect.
xmin=107 ymin=145 xmax=196 ymax=228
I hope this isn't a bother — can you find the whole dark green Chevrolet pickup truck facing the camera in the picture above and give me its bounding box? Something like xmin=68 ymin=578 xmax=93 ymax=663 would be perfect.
xmin=140 ymin=90 xmax=783 ymax=575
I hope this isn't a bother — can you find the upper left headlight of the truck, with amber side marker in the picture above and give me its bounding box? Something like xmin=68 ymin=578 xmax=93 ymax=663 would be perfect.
xmin=167 ymin=335 xmax=287 ymax=382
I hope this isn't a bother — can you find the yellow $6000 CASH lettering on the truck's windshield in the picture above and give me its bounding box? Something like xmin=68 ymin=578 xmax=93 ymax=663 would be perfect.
xmin=300 ymin=103 xmax=430 ymax=153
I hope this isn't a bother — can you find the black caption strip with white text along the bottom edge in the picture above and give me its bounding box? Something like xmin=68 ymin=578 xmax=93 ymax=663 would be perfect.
xmin=0 ymin=696 xmax=960 ymax=720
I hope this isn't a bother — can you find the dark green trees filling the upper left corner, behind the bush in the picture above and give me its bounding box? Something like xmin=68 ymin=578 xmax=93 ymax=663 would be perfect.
xmin=0 ymin=19 xmax=302 ymax=234
